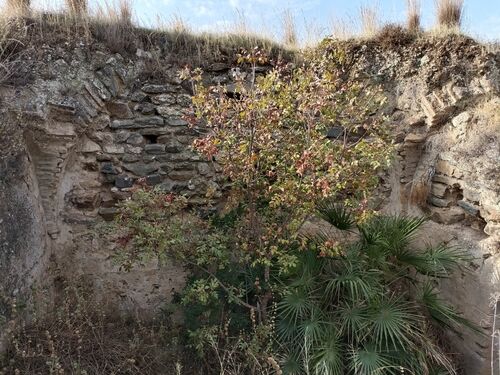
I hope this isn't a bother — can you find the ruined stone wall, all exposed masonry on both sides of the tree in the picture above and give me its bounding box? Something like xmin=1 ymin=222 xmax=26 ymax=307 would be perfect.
xmin=0 ymin=34 xmax=500 ymax=375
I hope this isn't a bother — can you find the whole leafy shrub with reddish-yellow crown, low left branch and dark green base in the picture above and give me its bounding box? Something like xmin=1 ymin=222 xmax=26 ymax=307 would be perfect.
xmin=112 ymin=42 xmax=392 ymax=374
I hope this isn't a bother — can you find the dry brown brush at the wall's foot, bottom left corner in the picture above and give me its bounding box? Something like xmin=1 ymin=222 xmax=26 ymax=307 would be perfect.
xmin=0 ymin=285 xmax=182 ymax=375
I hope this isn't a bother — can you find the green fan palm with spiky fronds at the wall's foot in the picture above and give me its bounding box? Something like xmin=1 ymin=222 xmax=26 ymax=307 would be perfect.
xmin=277 ymin=204 xmax=479 ymax=375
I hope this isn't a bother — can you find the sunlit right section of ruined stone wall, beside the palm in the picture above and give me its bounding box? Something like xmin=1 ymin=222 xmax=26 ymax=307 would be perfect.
xmin=353 ymin=37 xmax=500 ymax=375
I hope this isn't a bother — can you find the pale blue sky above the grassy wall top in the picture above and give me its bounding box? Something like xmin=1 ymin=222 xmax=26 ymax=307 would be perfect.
xmin=18 ymin=0 xmax=500 ymax=40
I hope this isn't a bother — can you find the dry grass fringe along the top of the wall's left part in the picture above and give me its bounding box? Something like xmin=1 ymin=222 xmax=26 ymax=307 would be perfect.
xmin=0 ymin=0 xmax=296 ymax=65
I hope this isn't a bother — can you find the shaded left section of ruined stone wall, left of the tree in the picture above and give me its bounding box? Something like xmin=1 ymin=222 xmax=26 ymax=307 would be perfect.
xmin=0 ymin=47 xmax=240 ymax=320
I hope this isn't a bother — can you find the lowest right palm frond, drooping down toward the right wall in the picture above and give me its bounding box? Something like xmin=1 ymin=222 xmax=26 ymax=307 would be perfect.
xmin=420 ymin=283 xmax=484 ymax=335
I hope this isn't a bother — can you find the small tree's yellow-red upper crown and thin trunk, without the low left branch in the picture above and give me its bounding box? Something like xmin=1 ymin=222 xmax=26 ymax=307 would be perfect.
xmin=184 ymin=42 xmax=392 ymax=321
